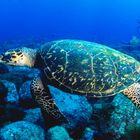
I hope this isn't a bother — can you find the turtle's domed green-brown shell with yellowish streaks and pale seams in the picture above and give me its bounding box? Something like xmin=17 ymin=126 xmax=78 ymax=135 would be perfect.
xmin=40 ymin=40 xmax=140 ymax=97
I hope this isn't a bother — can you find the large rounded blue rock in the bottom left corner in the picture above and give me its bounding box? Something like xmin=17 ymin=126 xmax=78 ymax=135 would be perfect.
xmin=0 ymin=121 xmax=45 ymax=140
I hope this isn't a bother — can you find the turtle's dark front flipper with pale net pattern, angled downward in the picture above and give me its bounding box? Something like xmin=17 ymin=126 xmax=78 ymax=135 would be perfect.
xmin=31 ymin=78 xmax=68 ymax=128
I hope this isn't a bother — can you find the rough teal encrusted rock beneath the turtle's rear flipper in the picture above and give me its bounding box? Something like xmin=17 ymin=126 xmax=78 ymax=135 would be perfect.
xmin=109 ymin=94 xmax=140 ymax=137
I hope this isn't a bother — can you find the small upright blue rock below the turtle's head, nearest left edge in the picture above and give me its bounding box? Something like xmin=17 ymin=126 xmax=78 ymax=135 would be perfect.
xmin=2 ymin=80 xmax=19 ymax=104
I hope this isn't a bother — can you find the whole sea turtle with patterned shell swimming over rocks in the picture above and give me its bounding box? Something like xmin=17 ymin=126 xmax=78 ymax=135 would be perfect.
xmin=0 ymin=39 xmax=140 ymax=125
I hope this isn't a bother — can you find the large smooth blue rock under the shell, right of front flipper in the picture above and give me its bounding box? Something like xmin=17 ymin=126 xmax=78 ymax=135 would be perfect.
xmin=49 ymin=86 xmax=92 ymax=127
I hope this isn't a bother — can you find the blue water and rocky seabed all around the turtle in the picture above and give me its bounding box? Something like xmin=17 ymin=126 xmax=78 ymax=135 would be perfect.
xmin=0 ymin=0 xmax=140 ymax=140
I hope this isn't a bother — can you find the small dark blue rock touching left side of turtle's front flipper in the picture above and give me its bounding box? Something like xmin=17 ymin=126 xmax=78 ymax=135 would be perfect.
xmin=19 ymin=81 xmax=36 ymax=108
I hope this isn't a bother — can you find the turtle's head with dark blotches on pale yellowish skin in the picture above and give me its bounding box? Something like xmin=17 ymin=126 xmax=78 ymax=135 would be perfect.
xmin=0 ymin=47 xmax=37 ymax=67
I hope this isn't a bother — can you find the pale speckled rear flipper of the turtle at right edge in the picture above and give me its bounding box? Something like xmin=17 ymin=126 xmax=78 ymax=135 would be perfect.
xmin=123 ymin=83 xmax=140 ymax=109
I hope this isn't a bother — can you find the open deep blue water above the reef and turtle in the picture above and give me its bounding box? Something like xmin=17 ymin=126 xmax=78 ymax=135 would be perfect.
xmin=0 ymin=0 xmax=140 ymax=43
